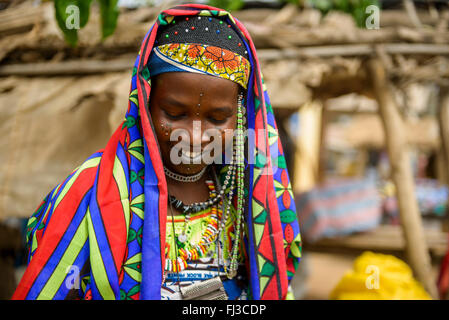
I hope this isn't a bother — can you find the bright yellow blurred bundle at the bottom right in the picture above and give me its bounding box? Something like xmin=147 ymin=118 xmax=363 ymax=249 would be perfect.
xmin=330 ymin=252 xmax=431 ymax=300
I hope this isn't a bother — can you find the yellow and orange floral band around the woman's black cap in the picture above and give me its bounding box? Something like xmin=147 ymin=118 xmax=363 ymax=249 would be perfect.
xmin=152 ymin=43 xmax=251 ymax=89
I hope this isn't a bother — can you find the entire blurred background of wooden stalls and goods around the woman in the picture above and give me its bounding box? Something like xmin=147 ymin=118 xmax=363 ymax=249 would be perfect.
xmin=0 ymin=0 xmax=449 ymax=299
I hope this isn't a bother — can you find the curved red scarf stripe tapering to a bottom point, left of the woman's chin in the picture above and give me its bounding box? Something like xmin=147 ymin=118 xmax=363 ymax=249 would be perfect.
xmin=96 ymin=127 xmax=127 ymax=274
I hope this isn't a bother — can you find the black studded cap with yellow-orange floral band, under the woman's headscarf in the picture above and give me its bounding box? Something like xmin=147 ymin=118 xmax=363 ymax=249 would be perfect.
xmin=148 ymin=16 xmax=251 ymax=89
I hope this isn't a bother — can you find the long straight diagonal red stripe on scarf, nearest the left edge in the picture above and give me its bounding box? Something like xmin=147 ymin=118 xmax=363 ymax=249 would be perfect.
xmin=12 ymin=167 xmax=97 ymax=300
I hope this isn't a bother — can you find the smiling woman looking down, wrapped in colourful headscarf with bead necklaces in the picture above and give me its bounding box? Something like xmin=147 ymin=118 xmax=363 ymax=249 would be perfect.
xmin=13 ymin=5 xmax=301 ymax=299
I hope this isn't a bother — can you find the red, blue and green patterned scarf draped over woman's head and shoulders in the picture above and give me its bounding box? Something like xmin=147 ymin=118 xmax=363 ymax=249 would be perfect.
xmin=13 ymin=5 xmax=301 ymax=299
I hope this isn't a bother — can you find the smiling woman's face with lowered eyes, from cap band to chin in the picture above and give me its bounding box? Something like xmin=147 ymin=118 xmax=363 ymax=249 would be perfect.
xmin=150 ymin=72 xmax=239 ymax=175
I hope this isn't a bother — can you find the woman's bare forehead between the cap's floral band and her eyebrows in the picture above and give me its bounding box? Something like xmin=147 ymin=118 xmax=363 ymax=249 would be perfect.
xmin=152 ymin=72 xmax=239 ymax=102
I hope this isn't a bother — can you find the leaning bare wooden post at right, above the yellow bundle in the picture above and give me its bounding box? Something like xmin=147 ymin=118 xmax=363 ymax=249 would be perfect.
xmin=368 ymin=59 xmax=438 ymax=299
